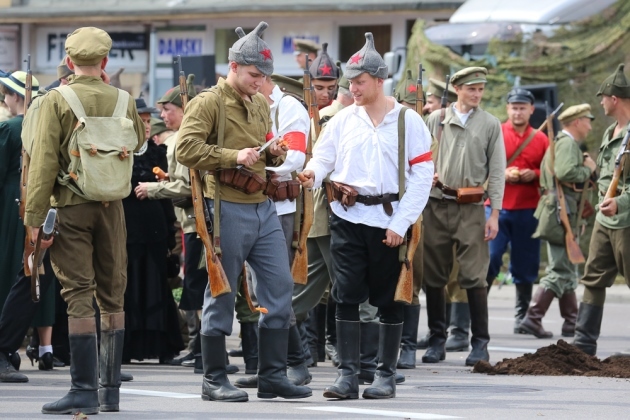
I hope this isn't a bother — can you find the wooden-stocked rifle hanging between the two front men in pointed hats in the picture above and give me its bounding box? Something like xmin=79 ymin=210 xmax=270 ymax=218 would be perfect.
xmin=291 ymin=54 xmax=321 ymax=284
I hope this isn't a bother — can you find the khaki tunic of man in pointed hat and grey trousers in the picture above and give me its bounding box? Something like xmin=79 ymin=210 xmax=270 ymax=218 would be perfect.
xmin=175 ymin=78 xmax=277 ymax=203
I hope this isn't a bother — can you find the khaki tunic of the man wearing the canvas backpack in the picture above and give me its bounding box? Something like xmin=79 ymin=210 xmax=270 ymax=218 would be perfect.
xmin=24 ymin=76 xmax=144 ymax=226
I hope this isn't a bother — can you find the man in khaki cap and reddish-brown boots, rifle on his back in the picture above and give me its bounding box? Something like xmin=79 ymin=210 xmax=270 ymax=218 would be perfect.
xmin=520 ymin=104 xmax=596 ymax=338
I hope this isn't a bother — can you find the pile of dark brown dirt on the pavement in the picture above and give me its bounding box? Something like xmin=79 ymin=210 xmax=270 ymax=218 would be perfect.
xmin=473 ymin=340 xmax=630 ymax=378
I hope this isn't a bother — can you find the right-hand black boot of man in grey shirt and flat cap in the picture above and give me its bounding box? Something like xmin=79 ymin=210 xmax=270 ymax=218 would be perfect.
xmin=466 ymin=287 xmax=490 ymax=366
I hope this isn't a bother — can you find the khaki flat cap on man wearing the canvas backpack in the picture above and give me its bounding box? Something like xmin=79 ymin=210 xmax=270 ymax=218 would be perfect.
xmin=66 ymin=27 xmax=112 ymax=66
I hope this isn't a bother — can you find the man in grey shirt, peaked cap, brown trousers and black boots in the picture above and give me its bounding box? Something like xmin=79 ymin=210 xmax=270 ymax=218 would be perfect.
xmin=423 ymin=67 xmax=505 ymax=366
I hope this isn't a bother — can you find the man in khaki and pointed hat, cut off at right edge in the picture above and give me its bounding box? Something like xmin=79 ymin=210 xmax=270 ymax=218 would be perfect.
xmin=573 ymin=64 xmax=630 ymax=356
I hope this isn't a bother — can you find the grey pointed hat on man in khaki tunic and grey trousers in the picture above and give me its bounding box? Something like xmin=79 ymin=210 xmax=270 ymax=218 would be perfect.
xmin=228 ymin=22 xmax=273 ymax=76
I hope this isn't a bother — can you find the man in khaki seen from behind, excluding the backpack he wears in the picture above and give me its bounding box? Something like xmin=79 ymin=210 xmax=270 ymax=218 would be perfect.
xmin=24 ymin=28 xmax=145 ymax=414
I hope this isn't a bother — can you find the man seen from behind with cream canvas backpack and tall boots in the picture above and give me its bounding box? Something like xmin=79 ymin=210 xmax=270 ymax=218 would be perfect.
xmin=24 ymin=27 xmax=145 ymax=414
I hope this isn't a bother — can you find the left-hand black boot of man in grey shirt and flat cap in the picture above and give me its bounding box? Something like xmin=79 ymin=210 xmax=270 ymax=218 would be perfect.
xmin=422 ymin=286 xmax=446 ymax=363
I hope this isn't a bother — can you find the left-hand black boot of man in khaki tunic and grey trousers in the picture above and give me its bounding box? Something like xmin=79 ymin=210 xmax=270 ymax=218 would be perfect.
xmin=204 ymin=332 xmax=248 ymax=402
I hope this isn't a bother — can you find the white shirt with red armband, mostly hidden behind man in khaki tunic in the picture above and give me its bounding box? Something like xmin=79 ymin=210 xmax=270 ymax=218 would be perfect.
xmin=265 ymin=85 xmax=311 ymax=216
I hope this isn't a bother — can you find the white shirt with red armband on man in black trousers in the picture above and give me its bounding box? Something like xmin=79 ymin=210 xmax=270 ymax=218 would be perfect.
xmin=306 ymin=97 xmax=433 ymax=236
